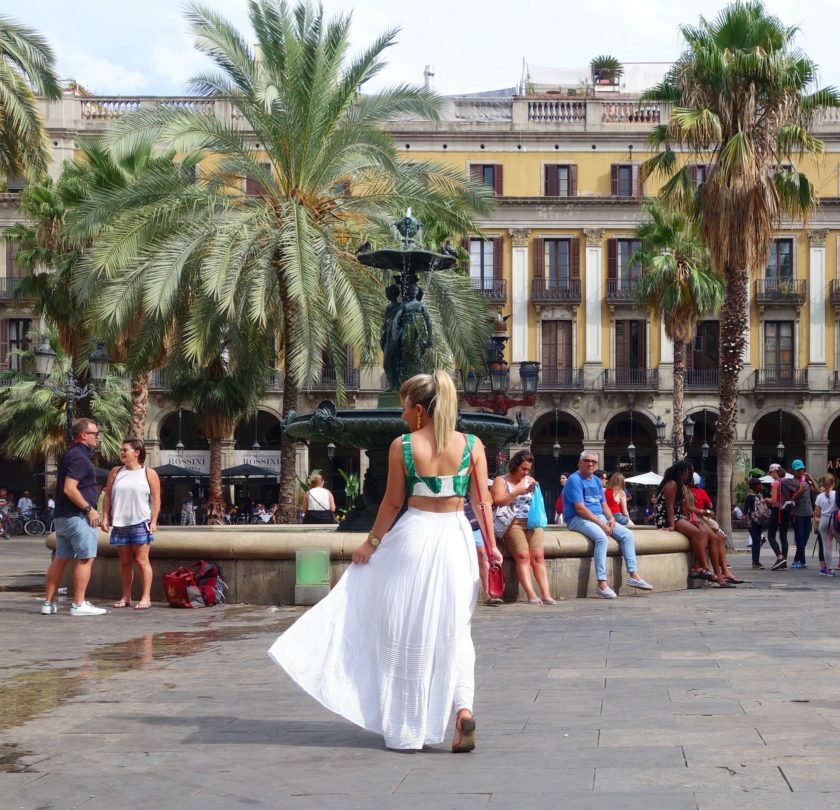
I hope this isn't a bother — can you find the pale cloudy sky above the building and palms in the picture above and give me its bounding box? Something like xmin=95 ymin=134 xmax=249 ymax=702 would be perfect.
xmin=6 ymin=0 xmax=840 ymax=95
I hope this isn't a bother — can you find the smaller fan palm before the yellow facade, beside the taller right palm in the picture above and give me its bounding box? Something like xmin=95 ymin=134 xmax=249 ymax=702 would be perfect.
xmin=630 ymin=198 xmax=723 ymax=458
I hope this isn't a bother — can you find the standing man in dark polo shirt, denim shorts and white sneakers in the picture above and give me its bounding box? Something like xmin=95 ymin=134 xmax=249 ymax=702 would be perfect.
xmin=41 ymin=419 xmax=107 ymax=616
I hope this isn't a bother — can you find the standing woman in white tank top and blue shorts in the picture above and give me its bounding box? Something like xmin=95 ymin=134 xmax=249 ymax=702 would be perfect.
xmin=102 ymin=439 xmax=160 ymax=610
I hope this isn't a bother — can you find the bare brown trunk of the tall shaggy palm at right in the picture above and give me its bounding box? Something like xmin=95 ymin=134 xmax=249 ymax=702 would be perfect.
xmin=715 ymin=267 xmax=749 ymax=548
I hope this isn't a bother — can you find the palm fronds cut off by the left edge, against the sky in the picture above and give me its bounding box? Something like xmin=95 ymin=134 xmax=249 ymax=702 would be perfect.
xmin=0 ymin=15 xmax=61 ymax=179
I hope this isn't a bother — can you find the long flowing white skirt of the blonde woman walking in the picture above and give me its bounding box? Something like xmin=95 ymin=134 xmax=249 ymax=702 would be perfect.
xmin=268 ymin=509 xmax=479 ymax=749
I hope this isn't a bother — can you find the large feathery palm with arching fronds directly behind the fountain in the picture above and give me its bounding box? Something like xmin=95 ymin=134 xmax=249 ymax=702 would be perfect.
xmin=93 ymin=0 xmax=492 ymax=521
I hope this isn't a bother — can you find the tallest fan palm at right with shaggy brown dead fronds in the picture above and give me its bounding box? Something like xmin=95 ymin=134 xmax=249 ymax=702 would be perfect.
xmin=642 ymin=0 xmax=840 ymax=526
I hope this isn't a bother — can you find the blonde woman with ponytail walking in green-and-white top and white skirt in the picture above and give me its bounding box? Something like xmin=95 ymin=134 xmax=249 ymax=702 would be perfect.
xmin=269 ymin=370 xmax=501 ymax=752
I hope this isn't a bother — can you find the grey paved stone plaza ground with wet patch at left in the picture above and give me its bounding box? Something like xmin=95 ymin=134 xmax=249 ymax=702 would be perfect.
xmin=0 ymin=539 xmax=840 ymax=810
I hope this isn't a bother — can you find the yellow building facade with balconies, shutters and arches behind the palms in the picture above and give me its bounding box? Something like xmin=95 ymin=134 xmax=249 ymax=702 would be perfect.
xmin=0 ymin=95 xmax=840 ymax=508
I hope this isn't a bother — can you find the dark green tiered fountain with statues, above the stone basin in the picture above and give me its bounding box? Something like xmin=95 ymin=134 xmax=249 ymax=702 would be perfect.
xmin=285 ymin=209 xmax=531 ymax=531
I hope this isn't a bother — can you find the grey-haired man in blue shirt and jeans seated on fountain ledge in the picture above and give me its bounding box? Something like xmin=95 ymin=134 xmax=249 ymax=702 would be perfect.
xmin=563 ymin=450 xmax=653 ymax=599
